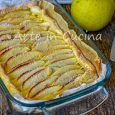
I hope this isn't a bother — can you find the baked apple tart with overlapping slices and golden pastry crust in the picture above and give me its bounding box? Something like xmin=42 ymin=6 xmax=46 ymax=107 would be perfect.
xmin=0 ymin=1 xmax=101 ymax=100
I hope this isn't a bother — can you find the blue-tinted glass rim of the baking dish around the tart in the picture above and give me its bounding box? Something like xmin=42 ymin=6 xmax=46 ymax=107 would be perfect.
xmin=0 ymin=0 xmax=112 ymax=108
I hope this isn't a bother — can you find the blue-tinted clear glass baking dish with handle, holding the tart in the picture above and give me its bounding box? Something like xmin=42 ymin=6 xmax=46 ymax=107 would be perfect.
xmin=0 ymin=0 xmax=111 ymax=115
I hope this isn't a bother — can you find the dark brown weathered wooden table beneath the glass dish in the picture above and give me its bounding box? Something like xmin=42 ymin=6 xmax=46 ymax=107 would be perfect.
xmin=0 ymin=5 xmax=115 ymax=115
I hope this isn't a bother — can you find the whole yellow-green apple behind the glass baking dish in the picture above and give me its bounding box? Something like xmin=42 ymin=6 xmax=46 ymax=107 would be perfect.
xmin=71 ymin=0 xmax=115 ymax=31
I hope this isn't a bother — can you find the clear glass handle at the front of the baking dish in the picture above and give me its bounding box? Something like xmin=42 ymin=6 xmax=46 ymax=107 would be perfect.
xmin=41 ymin=86 xmax=108 ymax=115
